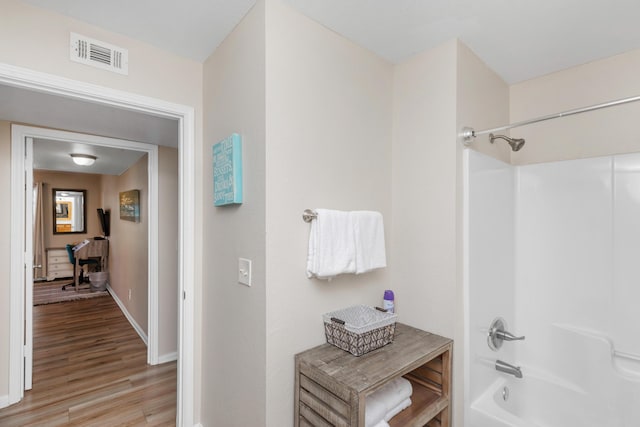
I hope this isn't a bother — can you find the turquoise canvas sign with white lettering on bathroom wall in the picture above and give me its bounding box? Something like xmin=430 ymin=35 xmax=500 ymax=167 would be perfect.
xmin=213 ymin=133 xmax=242 ymax=206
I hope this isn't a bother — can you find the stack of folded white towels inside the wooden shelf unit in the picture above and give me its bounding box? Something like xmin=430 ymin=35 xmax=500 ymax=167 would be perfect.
xmin=365 ymin=377 xmax=413 ymax=427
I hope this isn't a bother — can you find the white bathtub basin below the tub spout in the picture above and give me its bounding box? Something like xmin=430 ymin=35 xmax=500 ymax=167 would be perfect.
xmin=465 ymin=367 xmax=640 ymax=427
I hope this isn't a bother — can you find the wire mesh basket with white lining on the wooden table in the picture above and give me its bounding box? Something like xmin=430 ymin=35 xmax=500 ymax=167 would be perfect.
xmin=323 ymin=305 xmax=398 ymax=356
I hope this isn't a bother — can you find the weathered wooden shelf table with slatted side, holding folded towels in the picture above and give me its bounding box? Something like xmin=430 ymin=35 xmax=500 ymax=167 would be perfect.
xmin=294 ymin=323 xmax=453 ymax=427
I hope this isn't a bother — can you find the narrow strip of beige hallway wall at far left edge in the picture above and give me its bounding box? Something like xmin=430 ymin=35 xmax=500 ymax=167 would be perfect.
xmin=0 ymin=121 xmax=11 ymax=399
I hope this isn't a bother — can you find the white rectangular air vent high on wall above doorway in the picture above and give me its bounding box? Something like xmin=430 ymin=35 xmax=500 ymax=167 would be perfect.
xmin=69 ymin=33 xmax=129 ymax=75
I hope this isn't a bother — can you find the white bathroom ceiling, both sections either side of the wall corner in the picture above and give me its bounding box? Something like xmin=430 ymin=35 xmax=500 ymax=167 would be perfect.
xmin=23 ymin=0 xmax=640 ymax=83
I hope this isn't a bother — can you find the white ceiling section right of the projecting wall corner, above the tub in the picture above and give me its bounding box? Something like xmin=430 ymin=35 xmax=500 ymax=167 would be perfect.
xmin=285 ymin=0 xmax=640 ymax=83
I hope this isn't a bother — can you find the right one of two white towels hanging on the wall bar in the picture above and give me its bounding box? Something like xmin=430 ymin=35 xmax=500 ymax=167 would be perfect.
xmin=351 ymin=211 xmax=387 ymax=274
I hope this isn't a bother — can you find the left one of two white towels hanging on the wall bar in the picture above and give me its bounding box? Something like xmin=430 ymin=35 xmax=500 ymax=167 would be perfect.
xmin=307 ymin=209 xmax=356 ymax=279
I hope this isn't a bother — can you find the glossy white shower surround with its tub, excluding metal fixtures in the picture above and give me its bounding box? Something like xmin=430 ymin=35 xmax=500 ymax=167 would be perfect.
xmin=464 ymin=149 xmax=640 ymax=427
